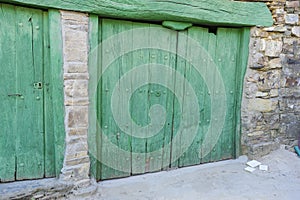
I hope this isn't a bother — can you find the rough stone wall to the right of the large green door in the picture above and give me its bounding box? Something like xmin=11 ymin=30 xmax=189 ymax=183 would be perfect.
xmin=242 ymin=0 xmax=300 ymax=157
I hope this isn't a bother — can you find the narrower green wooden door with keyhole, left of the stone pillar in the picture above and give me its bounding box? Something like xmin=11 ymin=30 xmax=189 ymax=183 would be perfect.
xmin=0 ymin=4 xmax=62 ymax=182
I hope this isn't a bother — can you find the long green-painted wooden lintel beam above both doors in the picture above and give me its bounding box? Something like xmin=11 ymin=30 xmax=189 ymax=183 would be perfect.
xmin=1 ymin=0 xmax=273 ymax=26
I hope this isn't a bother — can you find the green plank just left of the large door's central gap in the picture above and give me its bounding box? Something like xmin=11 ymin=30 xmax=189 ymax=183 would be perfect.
xmin=146 ymin=25 xmax=177 ymax=172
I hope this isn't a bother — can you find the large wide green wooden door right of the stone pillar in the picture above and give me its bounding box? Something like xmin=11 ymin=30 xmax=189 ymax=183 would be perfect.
xmin=90 ymin=19 xmax=248 ymax=180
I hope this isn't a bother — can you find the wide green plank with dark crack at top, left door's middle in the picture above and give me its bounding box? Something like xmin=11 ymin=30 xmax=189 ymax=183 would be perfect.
xmin=16 ymin=7 xmax=44 ymax=180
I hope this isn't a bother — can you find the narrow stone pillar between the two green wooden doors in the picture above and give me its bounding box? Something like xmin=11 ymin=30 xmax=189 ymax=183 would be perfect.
xmin=61 ymin=11 xmax=90 ymax=187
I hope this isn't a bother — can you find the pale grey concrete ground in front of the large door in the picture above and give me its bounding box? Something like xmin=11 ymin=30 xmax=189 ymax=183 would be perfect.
xmin=79 ymin=149 xmax=300 ymax=200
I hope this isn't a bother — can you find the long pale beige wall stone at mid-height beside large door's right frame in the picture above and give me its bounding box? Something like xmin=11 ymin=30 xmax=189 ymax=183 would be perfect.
xmin=248 ymin=99 xmax=278 ymax=112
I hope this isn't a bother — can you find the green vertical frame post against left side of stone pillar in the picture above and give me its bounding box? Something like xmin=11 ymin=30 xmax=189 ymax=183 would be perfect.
xmin=49 ymin=10 xmax=65 ymax=176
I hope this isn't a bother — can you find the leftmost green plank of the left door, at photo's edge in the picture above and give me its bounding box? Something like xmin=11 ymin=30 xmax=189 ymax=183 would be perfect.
xmin=0 ymin=4 xmax=19 ymax=182
